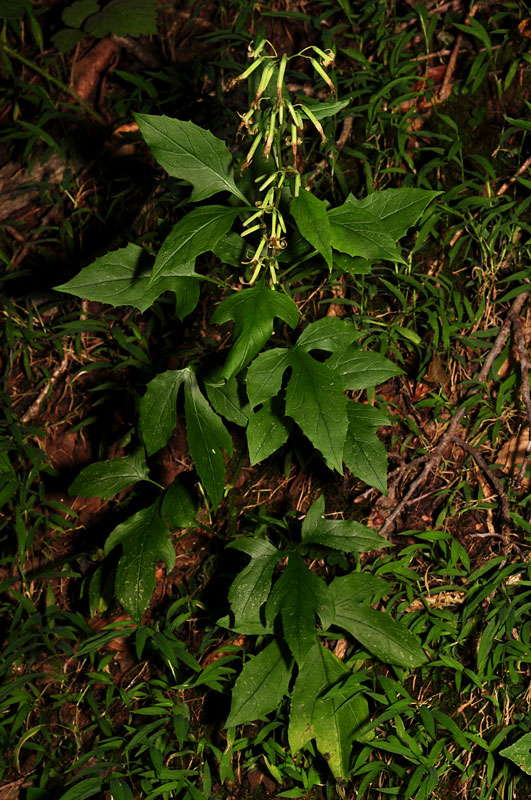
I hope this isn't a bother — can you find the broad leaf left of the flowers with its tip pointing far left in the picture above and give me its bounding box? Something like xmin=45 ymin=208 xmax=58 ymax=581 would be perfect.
xmin=54 ymin=244 xmax=193 ymax=311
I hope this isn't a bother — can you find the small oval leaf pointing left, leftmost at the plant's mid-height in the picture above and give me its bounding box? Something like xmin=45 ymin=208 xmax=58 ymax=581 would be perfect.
xmin=68 ymin=449 xmax=149 ymax=500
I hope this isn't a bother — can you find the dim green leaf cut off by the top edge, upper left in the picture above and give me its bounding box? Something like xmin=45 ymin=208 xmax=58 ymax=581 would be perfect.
xmin=84 ymin=0 xmax=157 ymax=39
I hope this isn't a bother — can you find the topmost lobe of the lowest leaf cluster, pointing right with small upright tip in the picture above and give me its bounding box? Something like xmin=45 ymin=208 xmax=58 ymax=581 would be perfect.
xmin=301 ymin=495 xmax=390 ymax=553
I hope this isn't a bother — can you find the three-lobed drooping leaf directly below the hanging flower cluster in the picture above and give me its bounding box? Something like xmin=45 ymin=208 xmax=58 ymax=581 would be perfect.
xmin=211 ymin=284 xmax=299 ymax=380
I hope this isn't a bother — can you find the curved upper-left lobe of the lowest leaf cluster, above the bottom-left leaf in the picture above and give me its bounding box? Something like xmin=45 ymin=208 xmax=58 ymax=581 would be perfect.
xmin=228 ymin=538 xmax=282 ymax=635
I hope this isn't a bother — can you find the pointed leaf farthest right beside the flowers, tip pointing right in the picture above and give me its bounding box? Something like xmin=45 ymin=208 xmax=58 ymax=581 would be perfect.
xmin=347 ymin=188 xmax=442 ymax=241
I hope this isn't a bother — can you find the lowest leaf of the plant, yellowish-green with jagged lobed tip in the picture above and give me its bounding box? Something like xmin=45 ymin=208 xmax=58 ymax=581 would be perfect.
xmin=288 ymin=644 xmax=369 ymax=779
